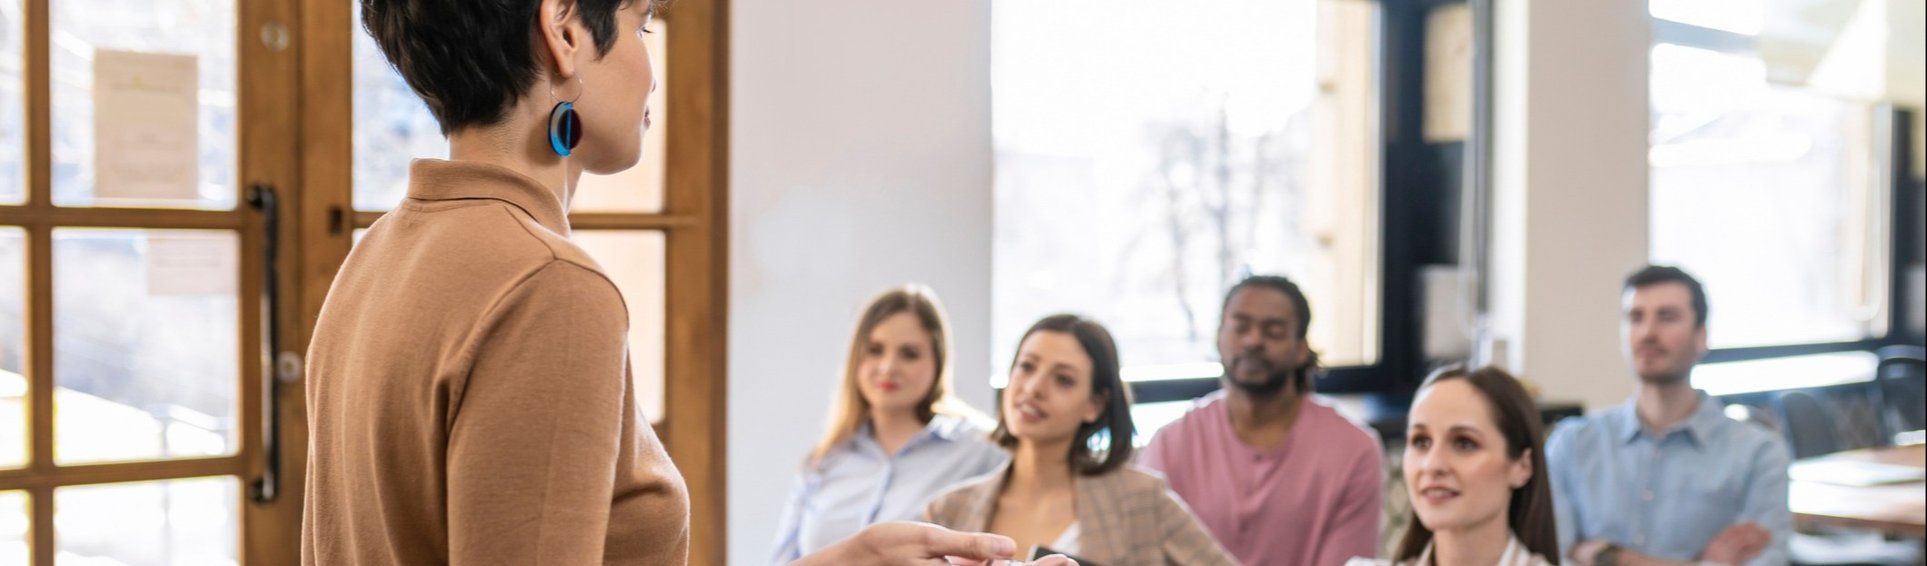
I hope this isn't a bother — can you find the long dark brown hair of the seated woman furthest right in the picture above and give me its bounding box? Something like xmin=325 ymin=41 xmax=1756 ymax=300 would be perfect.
xmin=1393 ymin=366 xmax=1559 ymax=566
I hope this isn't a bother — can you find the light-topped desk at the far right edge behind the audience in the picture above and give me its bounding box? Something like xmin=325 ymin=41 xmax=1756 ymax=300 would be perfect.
xmin=1788 ymin=445 xmax=1927 ymax=537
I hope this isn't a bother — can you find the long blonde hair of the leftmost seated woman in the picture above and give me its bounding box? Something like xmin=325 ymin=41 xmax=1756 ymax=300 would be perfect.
xmin=809 ymin=283 xmax=977 ymax=466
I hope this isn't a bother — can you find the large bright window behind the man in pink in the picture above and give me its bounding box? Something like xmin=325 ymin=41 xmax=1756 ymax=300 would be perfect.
xmin=990 ymin=0 xmax=1380 ymax=411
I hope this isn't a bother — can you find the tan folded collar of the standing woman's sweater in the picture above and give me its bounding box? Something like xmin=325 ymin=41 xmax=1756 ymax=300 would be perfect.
xmin=409 ymin=160 xmax=568 ymax=237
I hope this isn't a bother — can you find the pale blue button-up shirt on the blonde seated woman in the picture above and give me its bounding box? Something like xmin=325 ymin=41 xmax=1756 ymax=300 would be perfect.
xmin=771 ymin=414 xmax=1010 ymax=564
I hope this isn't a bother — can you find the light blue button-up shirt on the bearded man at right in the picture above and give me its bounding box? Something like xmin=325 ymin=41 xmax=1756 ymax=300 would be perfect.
xmin=1545 ymin=393 xmax=1794 ymax=566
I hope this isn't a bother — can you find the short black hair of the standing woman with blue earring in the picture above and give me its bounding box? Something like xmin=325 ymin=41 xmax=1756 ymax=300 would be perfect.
xmin=360 ymin=0 xmax=639 ymax=135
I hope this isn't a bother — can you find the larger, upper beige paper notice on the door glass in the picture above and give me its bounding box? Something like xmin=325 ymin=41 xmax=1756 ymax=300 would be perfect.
xmin=94 ymin=50 xmax=200 ymax=200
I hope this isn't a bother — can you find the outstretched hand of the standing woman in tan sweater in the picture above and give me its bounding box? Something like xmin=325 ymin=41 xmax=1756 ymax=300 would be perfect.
xmin=796 ymin=522 xmax=1075 ymax=566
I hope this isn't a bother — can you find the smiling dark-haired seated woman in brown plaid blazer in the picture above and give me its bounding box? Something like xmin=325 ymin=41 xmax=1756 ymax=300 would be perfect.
xmin=925 ymin=314 xmax=1237 ymax=566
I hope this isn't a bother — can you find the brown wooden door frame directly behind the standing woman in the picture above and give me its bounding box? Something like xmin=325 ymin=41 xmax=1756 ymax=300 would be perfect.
xmin=292 ymin=0 xmax=728 ymax=564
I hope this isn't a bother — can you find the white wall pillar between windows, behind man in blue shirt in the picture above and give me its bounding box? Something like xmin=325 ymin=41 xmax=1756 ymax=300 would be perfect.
xmin=1490 ymin=0 xmax=1651 ymax=410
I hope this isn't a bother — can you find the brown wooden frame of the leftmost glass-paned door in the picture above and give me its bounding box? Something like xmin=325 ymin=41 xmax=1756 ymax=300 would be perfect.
xmin=0 ymin=0 xmax=306 ymax=566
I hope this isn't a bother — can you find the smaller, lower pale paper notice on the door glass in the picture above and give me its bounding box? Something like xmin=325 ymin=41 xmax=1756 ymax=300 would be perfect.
xmin=146 ymin=233 xmax=241 ymax=296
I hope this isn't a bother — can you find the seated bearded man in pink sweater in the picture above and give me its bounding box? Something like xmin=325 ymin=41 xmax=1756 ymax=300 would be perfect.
xmin=1139 ymin=275 xmax=1386 ymax=566
